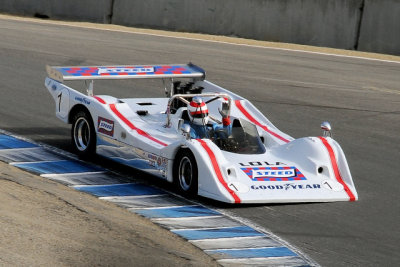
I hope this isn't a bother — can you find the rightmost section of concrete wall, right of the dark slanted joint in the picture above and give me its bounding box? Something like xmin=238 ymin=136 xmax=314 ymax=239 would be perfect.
xmin=358 ymin=0 xmax=400 ymax=55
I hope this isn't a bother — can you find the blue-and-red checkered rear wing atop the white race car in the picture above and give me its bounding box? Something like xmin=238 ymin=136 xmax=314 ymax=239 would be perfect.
xmin=46 ymin=63 xmax=206 ymax=82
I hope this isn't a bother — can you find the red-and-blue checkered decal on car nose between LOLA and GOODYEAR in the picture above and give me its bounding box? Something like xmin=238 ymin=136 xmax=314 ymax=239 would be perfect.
xmin=240 ymin=166 xmax=307 ymax=181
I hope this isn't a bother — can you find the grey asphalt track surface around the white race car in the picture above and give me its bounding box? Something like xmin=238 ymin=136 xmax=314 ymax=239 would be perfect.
xmin=0 ymin=18 xmax=400 ymax=266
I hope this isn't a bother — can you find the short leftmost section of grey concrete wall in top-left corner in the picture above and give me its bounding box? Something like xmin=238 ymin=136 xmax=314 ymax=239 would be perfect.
xmin=0 ymin=0 xmax=113 ymax=23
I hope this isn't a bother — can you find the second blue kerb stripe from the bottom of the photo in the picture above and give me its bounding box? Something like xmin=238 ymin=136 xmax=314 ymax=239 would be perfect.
xmin=172 ymin=226 xmax=264 ymax=240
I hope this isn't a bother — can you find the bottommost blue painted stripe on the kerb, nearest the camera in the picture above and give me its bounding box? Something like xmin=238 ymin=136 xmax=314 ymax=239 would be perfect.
xmin=207 ymin=247 xmax=297 ymax=259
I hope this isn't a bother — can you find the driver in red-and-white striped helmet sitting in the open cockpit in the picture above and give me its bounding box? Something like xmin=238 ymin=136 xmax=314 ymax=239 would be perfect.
xmin=187 ymin=96 xmax=232 ymax=138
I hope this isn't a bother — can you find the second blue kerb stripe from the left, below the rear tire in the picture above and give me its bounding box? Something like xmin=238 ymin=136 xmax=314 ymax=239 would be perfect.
xmin=14 ymin=160 xmax=105 ymax=174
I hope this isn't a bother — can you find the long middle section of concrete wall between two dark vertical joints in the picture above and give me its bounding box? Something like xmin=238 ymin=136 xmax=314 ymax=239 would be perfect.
xmin=112 ymin=0 xmax=362 ymax=49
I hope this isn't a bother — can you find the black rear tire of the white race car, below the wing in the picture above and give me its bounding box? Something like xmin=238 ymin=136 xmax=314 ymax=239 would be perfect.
xmin=71 ymin=110 xmax=96 ymax=158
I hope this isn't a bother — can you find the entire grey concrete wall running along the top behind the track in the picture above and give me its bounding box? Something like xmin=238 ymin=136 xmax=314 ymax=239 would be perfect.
xmin=0 ymin=0 xmax=400 ymax=55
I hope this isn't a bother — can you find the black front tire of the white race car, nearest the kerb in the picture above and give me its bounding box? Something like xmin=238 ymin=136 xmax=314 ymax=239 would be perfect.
xmin=173 ymin=149 xmax=198 ymax=196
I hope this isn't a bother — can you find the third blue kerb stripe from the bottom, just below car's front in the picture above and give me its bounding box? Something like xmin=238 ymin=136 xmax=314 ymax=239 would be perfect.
xmin=135 ymin=206 xmax=221 ymax=218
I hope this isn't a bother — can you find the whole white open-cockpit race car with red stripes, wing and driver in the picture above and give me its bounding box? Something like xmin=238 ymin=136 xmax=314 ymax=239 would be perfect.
xmin=45 ymin=63 xmax=358 ymax=203
